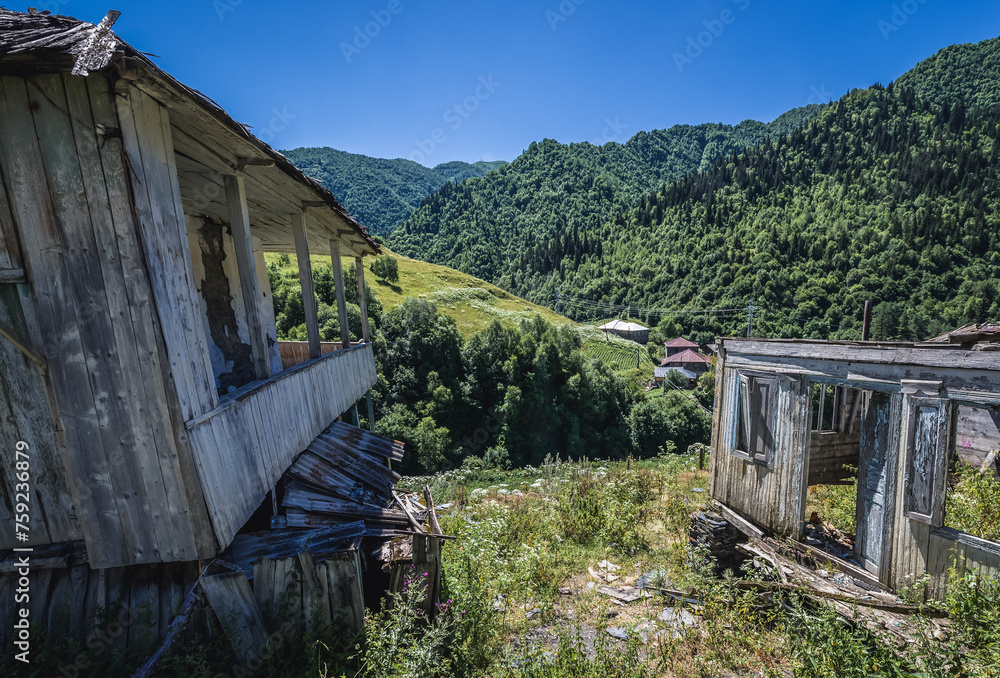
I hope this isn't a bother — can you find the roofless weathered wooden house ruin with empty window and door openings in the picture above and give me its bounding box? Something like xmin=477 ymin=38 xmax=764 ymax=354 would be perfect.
xmin=710 ymin=331 xmax=1000 ymax=597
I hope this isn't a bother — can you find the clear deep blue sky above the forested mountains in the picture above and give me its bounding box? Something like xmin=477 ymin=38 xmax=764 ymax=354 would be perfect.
xmin=54 ymin=0 xmax=1000 ymax=166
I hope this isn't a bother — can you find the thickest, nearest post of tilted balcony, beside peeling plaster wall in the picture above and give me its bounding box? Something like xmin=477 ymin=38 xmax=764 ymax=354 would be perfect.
xmin=226 ymin=174 xmax=271 ymax=379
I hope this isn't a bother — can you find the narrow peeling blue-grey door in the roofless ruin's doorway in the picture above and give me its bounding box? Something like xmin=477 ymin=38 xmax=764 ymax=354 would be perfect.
xmin=854 ymin=392 xmax=891 ymax=573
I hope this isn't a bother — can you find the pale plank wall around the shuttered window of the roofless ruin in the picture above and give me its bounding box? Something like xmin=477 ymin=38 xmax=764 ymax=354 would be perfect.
xmin=712 ymin=367 xmax=809 ymax=535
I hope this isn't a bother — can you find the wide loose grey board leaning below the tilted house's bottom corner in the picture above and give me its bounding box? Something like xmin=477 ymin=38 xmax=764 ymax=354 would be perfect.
xmin=201 ymin=572 xmax=267 ymax=661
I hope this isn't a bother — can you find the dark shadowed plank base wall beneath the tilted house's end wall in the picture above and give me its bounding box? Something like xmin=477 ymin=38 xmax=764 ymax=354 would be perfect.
xmin=0 ymin=562 xmax=200 ymax=654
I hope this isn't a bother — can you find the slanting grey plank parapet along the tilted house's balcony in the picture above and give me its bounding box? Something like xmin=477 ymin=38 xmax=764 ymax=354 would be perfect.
xmin=189 ymin=344 xmax=377 ymax=544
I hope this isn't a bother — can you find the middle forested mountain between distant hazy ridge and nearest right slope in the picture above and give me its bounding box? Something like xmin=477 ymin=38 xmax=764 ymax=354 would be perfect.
xmin=388 ymin=105 xmax=821 ymax=278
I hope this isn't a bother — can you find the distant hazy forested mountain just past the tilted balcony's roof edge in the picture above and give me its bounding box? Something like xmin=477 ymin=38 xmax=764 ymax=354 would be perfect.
xmin=282 ymin=148 xmax=507 ymax=235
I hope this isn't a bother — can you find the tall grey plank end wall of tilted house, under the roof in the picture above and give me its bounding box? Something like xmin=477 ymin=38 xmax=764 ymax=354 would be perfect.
xmin=0 ymin=74 xmax=215 ymax=567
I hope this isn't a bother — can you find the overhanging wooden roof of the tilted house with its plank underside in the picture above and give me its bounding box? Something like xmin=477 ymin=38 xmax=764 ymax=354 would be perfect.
xmin=0 ymin=8 xmax=381 ymax=256
